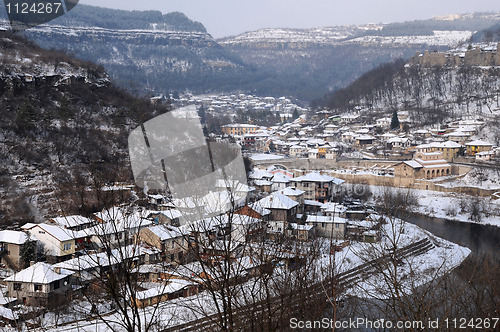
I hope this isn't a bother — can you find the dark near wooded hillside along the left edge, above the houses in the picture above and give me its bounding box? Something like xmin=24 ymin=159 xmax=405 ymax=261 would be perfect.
xmin=0 ymin=31 xmax=167 ymax=224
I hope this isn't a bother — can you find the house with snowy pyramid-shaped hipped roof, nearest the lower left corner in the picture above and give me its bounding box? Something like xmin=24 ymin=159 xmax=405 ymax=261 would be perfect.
xmin=5 ymin=262 xmax=73 ymax=307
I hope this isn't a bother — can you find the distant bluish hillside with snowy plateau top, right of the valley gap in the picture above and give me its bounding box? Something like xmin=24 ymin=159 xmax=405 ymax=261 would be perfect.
xmin=218 ymin=14 xmax=500 ymax=100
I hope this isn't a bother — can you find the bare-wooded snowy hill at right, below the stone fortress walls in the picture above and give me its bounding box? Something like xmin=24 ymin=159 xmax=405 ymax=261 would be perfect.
xmin=312 ymin=43 xmax=500 ymax=126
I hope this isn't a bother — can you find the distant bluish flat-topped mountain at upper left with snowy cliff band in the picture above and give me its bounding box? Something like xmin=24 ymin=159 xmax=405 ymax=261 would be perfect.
xmin=14 ymin=5 xmax=249 ymax=93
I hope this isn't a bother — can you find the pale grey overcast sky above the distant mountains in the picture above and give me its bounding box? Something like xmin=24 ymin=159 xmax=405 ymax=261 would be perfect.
xmin=80 ymin=0 xmax=500 ymax=38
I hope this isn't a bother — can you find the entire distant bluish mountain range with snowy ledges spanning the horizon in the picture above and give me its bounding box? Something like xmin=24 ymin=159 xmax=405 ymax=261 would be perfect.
xmin=10 ymin=5 xmax=500 ymax=101
